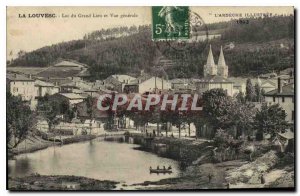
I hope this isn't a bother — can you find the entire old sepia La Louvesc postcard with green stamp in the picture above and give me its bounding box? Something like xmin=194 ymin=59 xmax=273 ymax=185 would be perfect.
xmin=6 ymin=6 xmax=295 ymax=191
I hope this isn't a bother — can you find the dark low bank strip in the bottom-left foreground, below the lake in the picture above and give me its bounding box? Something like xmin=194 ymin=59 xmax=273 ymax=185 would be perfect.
xmin=8 ymin=174 xmax=118 ymax=191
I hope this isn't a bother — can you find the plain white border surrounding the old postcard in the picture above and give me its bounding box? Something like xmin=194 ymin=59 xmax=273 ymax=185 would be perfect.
xmin=0 ymin=0 xmax=300 ymax=195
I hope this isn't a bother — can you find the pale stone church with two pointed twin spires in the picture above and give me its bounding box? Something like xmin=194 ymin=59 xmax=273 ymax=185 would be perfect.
xmin=196 ymin=45 xmax=234 ymax=96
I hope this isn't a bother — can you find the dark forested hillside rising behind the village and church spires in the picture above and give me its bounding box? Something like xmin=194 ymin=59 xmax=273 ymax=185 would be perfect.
xmin=8 ymin=16 xmax=294 ymax=79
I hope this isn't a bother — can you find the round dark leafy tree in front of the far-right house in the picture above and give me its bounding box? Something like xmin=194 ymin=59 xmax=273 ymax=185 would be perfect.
xmin=253 ymin=103 xmax=288 ymax=140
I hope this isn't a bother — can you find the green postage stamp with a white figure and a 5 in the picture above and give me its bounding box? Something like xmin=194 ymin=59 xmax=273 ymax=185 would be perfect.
xmin=152 ymin=6 xmax=190 ymax=40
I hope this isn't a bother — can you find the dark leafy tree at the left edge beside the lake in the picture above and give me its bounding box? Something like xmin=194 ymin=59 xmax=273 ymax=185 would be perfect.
xmin=6 ymin=92 xmax=35 ymax=149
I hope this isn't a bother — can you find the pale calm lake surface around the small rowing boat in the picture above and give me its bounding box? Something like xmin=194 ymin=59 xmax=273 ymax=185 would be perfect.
xmin=9 ymin=140 xmax=179 ymax=184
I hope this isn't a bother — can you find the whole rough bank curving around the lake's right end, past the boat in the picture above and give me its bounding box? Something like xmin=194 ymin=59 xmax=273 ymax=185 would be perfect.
xmin=116 ymin=134 xmax=295 ymax=190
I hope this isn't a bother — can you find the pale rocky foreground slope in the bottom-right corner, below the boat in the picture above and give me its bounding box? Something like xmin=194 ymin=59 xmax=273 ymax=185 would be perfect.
xmin=132 ymin=151 xmax=295 ymax=191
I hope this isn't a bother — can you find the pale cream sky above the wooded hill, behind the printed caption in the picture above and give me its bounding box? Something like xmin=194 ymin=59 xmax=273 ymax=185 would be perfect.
xmin=7 ymin=7 xmax=294 ymax=59
